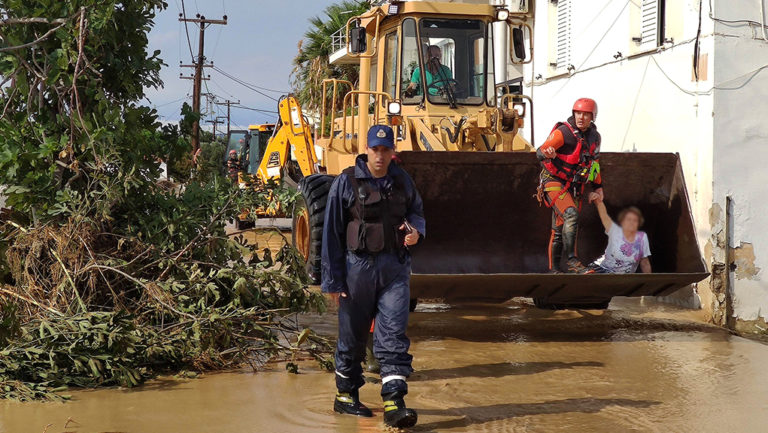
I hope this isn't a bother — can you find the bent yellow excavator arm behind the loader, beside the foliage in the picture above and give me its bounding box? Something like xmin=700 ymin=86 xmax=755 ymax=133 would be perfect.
xmin=258 ymin=95 xmax=317 ymax=183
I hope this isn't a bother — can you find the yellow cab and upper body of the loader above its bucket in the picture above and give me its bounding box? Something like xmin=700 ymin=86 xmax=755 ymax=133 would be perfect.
xmin=316 ymin=2 xmax=533 ymax=173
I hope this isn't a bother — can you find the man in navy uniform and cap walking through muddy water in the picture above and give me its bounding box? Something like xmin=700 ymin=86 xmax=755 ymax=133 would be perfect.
xmin=322 ymin=125 xmax=425 ymax=428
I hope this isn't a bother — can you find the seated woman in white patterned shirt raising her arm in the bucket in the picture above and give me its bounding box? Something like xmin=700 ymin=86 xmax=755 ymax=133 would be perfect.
xmin=589 ymin=192 xmax=651 ymax=274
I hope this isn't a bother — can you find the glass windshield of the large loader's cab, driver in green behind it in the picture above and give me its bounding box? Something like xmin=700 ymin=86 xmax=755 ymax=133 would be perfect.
xmin=403 ymin=19 xmax=487 ymax=105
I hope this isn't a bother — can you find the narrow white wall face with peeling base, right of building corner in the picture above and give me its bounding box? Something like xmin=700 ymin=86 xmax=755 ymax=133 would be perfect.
xmin=710 ymin=0 xmax=768 ymax=332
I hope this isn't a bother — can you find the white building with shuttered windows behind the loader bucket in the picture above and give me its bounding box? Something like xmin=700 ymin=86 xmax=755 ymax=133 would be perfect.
xmin=491 ymin=0 xmax=768 ymax=332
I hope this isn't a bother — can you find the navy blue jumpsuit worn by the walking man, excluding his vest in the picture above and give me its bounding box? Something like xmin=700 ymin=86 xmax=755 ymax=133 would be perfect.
xmin=322 ymin=155 xmax=426 ymax=395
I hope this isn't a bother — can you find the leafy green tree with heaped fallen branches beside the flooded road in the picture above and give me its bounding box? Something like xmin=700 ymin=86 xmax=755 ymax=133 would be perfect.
xmin=0 ymin=0 xmax=328 ymax=399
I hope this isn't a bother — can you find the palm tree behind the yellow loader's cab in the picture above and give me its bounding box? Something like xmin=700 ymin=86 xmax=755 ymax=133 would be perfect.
xmin=292 ymin=0 xmax=370 ymax=110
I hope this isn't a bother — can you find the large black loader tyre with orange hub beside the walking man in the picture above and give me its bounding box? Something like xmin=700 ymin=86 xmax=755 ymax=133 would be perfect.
xmin=292 ymin=174 xmax=334 ymax=284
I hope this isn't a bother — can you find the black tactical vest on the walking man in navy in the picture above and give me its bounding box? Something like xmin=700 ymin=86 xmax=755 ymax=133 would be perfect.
xmin=342 ymin=167 xmax=408 ymax=254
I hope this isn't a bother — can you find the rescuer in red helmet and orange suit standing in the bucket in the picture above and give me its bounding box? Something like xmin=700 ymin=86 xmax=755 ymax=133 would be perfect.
xmin=536 ymin=98 xmax=603 ymax=273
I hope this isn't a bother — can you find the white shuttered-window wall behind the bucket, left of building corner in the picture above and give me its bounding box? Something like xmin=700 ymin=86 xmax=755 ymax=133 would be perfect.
xmin=524 ymin=0 xmax=715 ymax=307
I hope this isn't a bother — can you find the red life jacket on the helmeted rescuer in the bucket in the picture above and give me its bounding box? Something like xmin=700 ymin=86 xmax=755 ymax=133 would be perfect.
xmin=541 ymin=122 xmax=600 ymax=184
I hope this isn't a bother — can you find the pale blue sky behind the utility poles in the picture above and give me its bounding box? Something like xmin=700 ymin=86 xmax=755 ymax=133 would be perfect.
xmin=145 ymin=0 xmax=333 ymax=131
